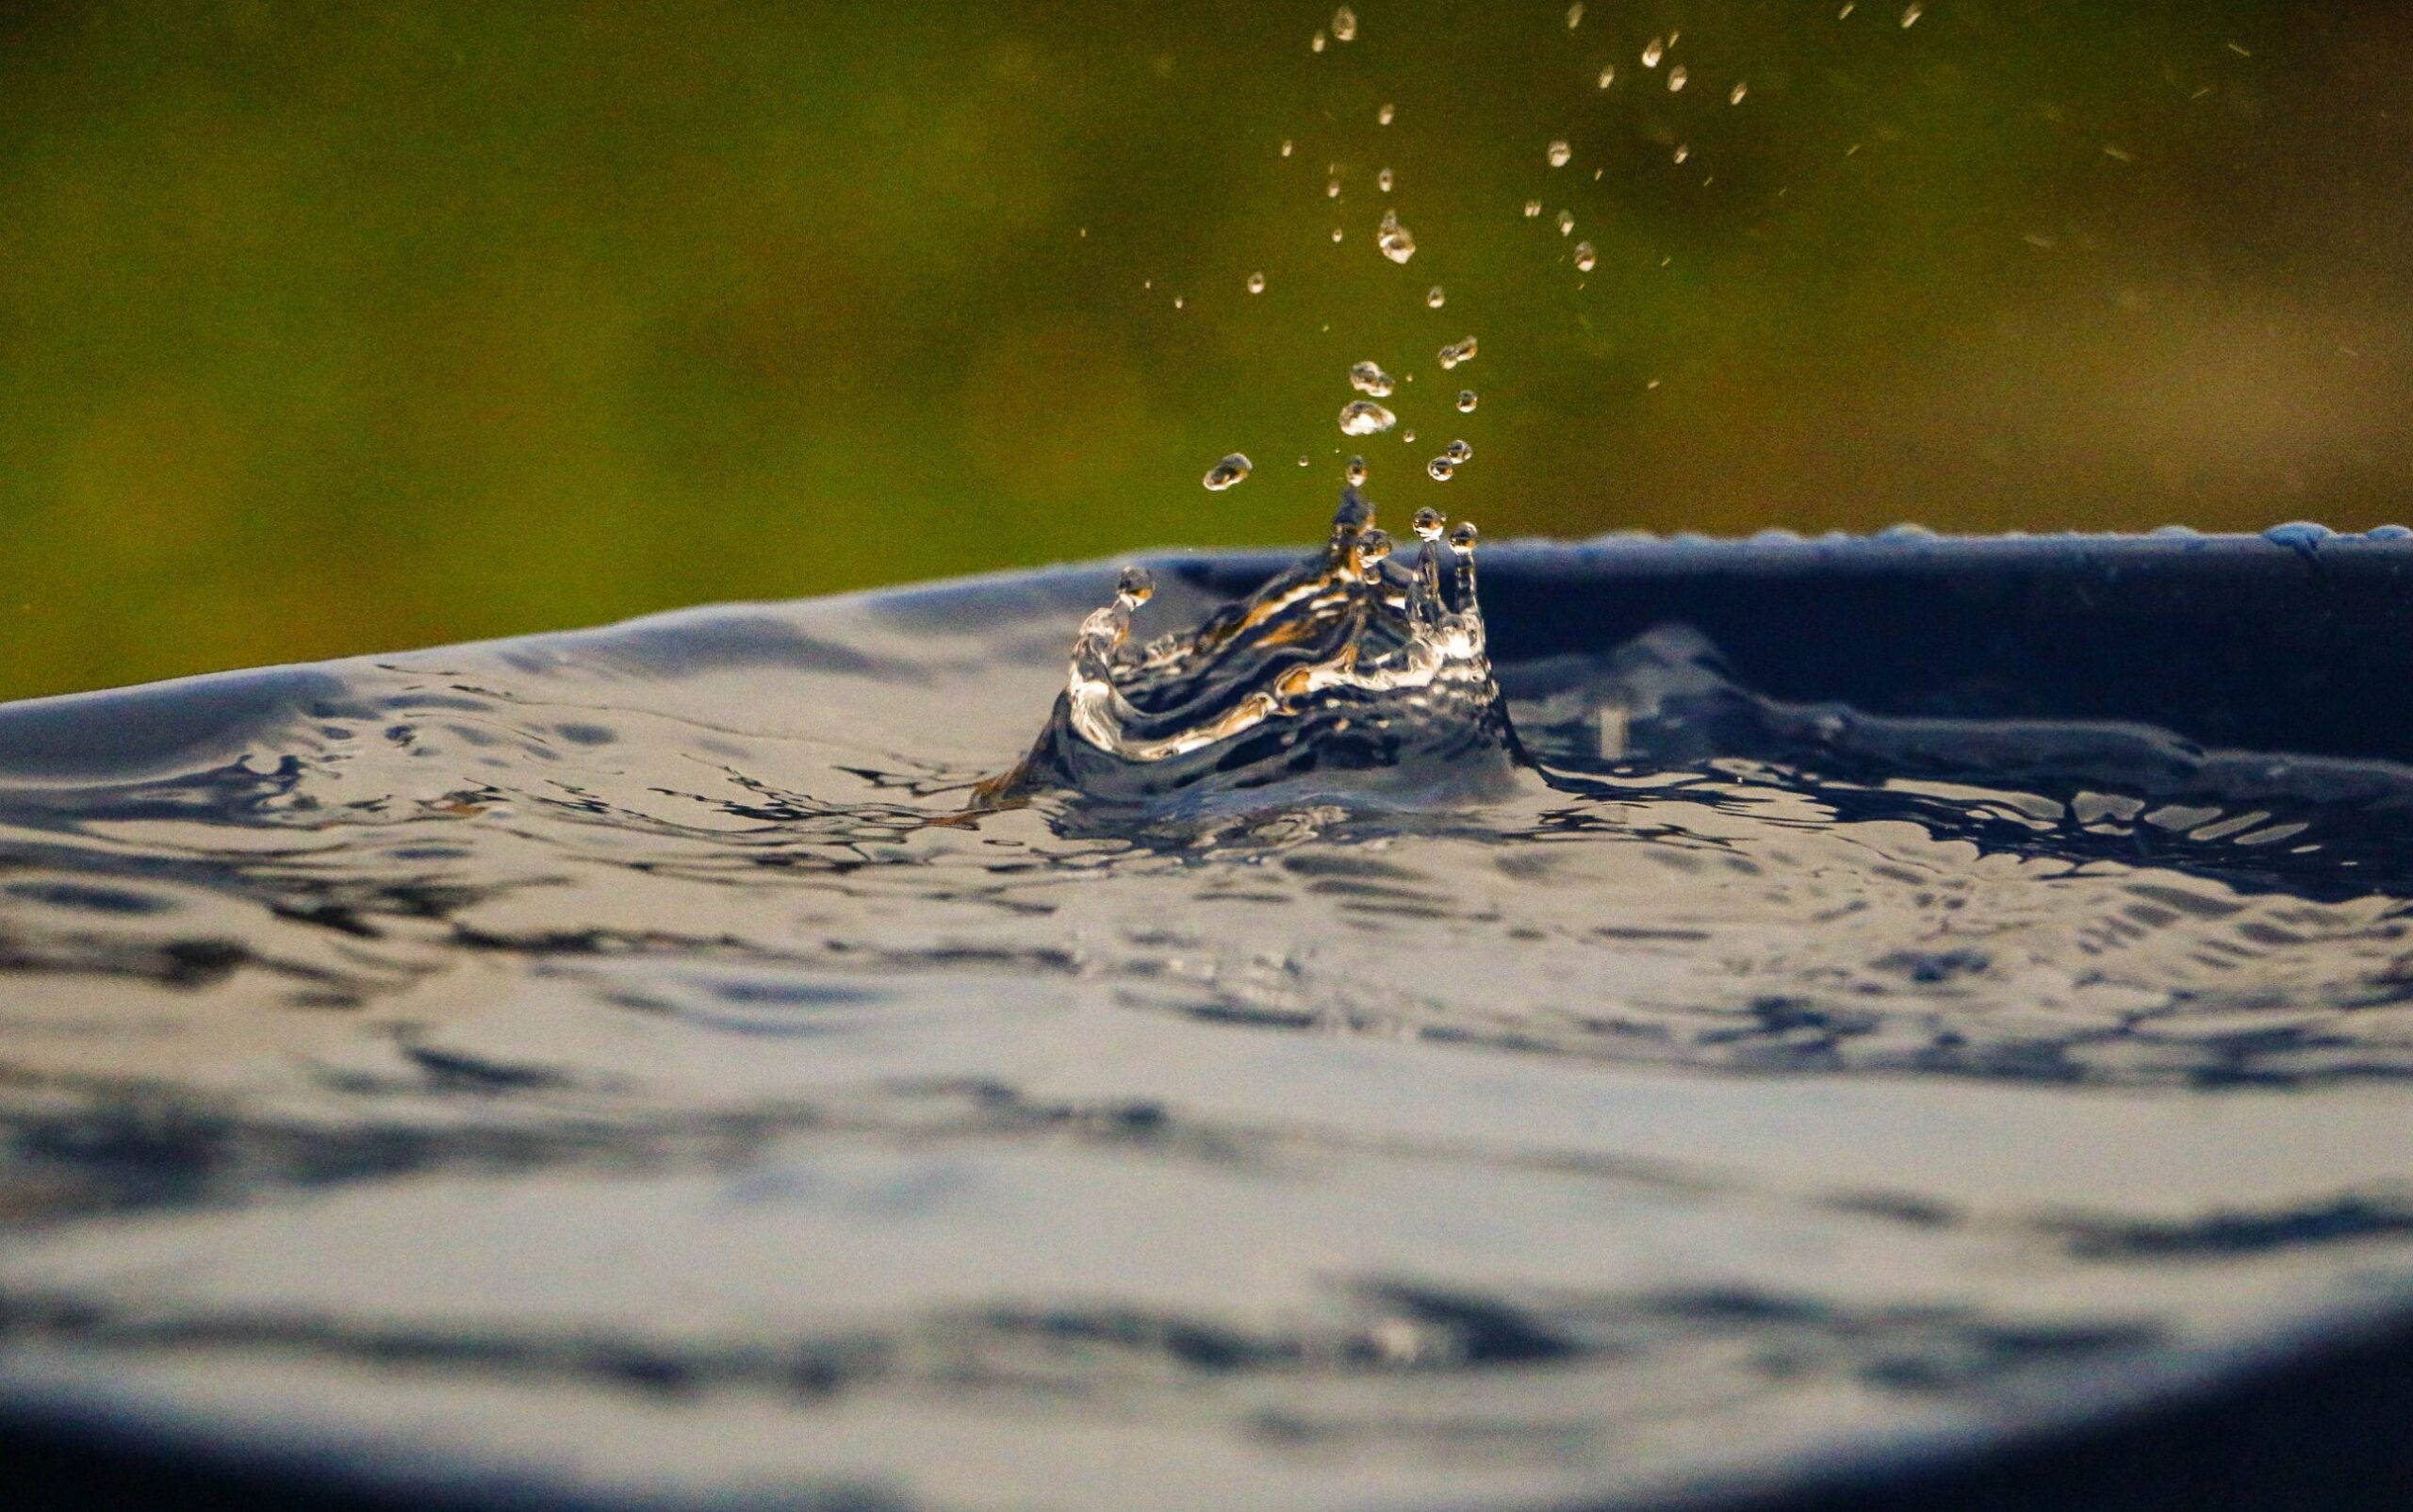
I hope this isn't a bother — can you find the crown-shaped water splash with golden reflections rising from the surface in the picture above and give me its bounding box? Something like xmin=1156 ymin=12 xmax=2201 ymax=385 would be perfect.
xmin=975 ymin=494 xmax=1518 ymax=805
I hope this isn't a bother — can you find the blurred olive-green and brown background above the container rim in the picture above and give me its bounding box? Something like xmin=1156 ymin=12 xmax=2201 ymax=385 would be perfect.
xmin=0 ymin=0 xmax=2413 ymax=695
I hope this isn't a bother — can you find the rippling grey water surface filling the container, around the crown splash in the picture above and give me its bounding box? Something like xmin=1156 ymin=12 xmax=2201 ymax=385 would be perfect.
xmin=0 ymin=530 xmax=2413 ymax=1507
